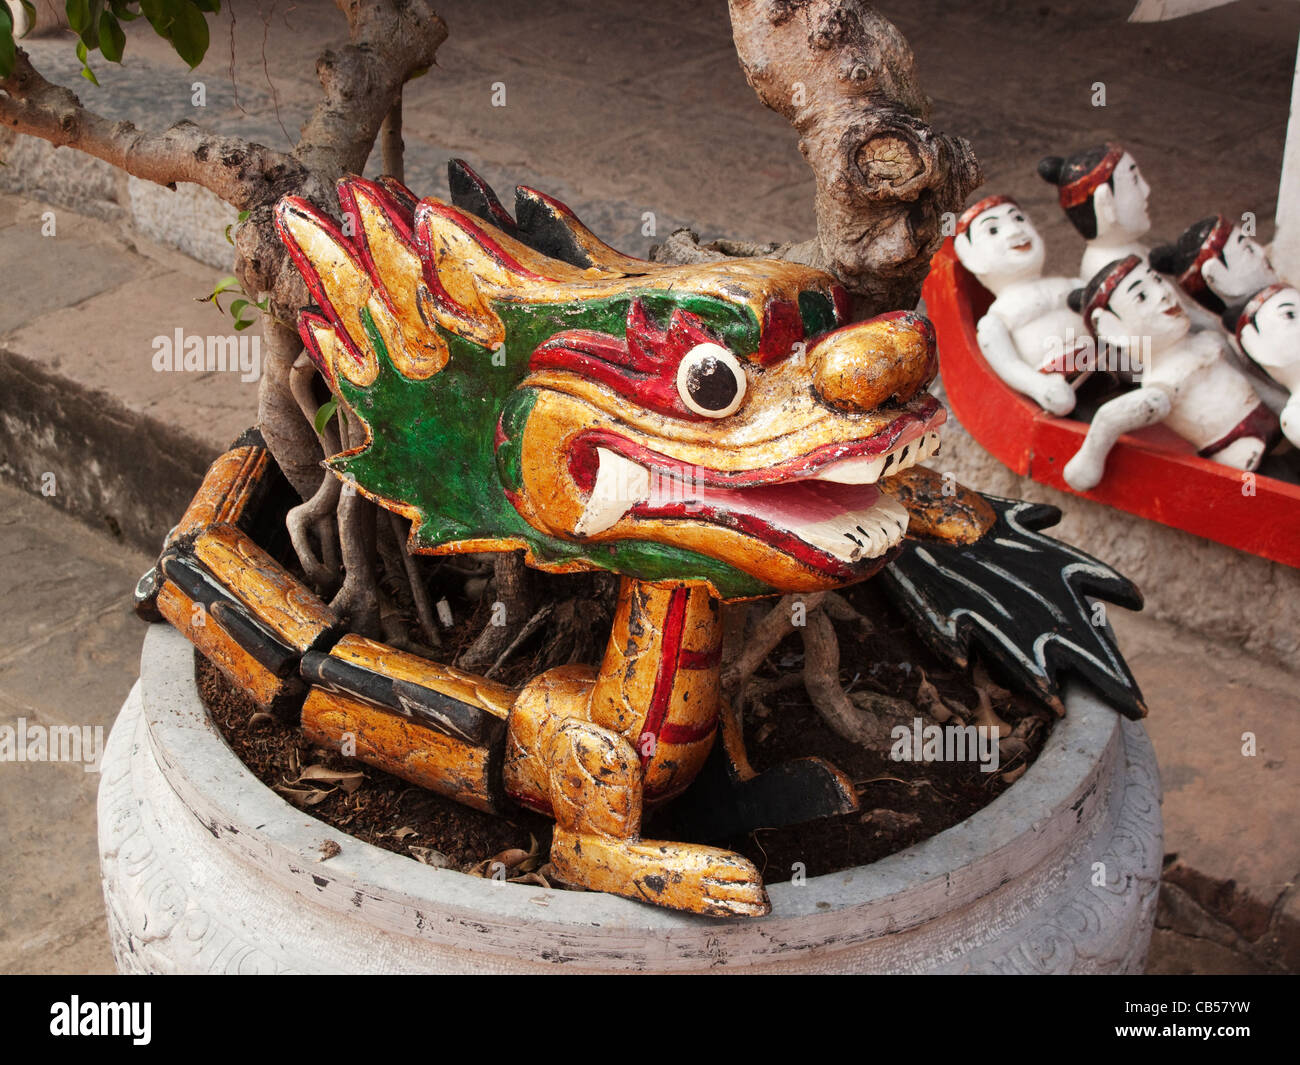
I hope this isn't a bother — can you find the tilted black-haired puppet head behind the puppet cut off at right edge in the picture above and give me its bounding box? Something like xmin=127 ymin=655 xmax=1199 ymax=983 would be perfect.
xmin=1151 ymin=215 xmax=1278 ymax=315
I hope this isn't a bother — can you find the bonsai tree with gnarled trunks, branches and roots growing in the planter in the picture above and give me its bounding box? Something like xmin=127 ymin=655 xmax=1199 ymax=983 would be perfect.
xmin=0 ymin=0 xmax=980 ymax=743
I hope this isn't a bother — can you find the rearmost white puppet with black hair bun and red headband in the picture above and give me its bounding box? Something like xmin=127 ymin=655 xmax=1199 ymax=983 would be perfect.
xmin=1039 ymin=144 xmax=1151 ymax=282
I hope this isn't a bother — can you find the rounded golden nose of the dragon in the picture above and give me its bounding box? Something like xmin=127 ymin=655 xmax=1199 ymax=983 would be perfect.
xmin=809 ymin=311 xmax=939 ymax=414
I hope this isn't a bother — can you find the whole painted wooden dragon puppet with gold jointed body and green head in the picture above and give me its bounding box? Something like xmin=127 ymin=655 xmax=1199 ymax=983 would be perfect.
xmin=137 ymin=161 xmax=1143 ymax=917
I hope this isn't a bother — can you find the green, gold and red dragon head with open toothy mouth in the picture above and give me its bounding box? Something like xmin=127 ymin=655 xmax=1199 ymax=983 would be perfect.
xmin=276 ymin=164 xmax=945 ymax=598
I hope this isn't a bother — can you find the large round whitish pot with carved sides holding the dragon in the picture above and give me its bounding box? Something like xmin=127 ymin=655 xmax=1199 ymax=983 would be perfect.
xmin=99 ymin=625 xmax=1161 ymax=973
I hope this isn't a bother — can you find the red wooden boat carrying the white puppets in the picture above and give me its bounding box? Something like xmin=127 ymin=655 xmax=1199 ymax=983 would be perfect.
xmin=924 ymin=239 xmax=1300 ymax=567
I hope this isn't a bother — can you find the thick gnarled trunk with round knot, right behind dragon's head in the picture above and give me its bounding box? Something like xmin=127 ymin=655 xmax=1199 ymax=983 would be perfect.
xmin=657 ymin=0 xmax=982 ymax=316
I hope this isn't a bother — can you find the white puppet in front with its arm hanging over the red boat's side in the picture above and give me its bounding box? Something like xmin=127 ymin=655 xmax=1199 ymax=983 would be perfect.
xmin=1063 ymin=255 xmax=1281 ymax=492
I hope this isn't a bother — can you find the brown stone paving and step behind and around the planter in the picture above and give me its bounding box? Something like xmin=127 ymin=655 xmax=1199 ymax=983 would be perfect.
xmin=0 ymin=0 xmax=1300 ymax=971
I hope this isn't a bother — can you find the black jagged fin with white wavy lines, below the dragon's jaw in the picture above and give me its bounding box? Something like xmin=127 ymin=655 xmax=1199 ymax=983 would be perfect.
xmin=881 ymin=495 xmax=1147 ymax=718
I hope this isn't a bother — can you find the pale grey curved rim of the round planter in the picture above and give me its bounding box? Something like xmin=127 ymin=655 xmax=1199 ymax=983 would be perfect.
xmin=126 ymin=624 xmax=1154 ymax=960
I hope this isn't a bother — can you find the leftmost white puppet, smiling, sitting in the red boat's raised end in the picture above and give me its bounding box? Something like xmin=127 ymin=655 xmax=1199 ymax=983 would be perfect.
xmin=953 ymin=196 xmax=1092 ymax=415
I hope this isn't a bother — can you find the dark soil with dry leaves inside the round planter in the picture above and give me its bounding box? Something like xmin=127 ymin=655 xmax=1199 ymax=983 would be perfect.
xmin=198 ymin=577 xmax=1054 ymax=886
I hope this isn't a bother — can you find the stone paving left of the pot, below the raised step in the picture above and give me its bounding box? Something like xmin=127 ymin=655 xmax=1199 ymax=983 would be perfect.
xmin=0 ymin=484 xmax=151 ymax=973
